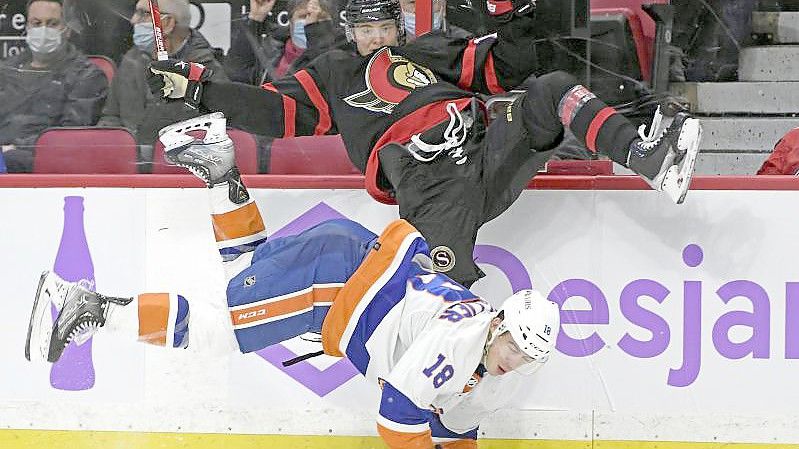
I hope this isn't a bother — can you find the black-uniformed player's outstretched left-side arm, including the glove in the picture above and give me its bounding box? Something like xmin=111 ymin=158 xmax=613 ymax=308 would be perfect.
xmin=148 ymin=60 xmax=337 ymax=138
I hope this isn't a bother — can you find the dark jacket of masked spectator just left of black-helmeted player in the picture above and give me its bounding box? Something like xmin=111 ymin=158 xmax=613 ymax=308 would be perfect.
xmin=225 ymin=19 xmax=347 ymax=85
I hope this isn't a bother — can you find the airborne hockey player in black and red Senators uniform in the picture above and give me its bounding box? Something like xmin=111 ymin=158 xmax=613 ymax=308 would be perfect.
xmin=149 ymin=0 xmax=701 ymax=286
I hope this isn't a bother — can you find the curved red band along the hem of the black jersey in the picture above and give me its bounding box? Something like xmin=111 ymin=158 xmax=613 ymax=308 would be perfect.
xmin=364 ymin=97 xmax=472 ymax=204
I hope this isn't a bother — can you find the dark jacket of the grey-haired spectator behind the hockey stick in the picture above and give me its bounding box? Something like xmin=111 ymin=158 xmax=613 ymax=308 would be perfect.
xmin=99 ymin=30 xmax=228 ymax=147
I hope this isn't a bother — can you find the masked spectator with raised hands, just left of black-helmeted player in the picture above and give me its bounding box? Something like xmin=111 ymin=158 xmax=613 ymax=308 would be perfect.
xmin=225 ymin=0 xmax=347 ymax=85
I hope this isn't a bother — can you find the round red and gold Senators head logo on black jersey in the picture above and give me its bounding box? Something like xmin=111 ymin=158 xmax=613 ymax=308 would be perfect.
xmin=344 ymin=48 xmax=437 ymax=114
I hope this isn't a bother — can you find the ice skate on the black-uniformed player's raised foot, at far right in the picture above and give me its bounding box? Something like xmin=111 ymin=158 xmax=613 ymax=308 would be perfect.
xmin=627 ymin=108 xmax=702 ymax=204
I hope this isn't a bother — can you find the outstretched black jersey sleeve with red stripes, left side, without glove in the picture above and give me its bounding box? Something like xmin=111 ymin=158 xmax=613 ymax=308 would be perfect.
xmin=202 ymin=64 xmax=338 ymax=138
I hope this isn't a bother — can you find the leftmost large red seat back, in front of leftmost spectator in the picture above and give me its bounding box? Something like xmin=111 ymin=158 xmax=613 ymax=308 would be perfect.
xmin=33 ymin=127 xmax=137 ymax=174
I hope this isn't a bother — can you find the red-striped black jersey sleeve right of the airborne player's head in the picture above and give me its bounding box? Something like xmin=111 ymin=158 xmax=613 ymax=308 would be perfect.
xmin=408 ymin=16 xmax=538 ymax=95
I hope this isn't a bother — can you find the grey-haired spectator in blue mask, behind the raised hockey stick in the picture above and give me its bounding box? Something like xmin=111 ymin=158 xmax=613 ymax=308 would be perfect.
xmin=99 ymin=0 xmax=227 ymax=161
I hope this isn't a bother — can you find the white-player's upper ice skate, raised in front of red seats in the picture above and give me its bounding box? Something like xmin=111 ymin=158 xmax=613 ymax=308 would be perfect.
xmin=158 ymin=112 xmax=245 ymax=204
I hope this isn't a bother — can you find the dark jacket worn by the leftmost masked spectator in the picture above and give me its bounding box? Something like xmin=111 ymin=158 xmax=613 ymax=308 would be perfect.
xmin=0 ymin=43 xmax=108 ymax=160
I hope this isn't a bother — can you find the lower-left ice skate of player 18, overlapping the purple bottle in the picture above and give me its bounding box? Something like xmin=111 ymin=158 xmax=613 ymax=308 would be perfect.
xmin=25 ymin=271 xmax=133 ymax=363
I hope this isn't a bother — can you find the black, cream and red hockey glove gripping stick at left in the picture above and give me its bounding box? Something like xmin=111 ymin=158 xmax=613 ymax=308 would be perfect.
xmin=147 ymin=59 xmax=213 ymax=109
